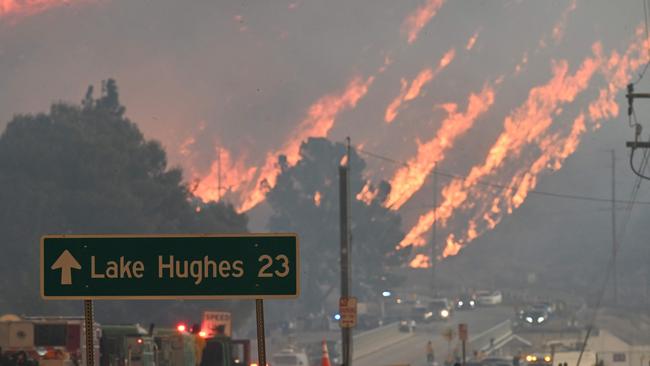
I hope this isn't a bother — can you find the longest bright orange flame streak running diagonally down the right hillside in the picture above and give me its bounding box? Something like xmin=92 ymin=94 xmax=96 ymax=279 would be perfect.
xmin=399 ymin=43 xmax=600 ymax=252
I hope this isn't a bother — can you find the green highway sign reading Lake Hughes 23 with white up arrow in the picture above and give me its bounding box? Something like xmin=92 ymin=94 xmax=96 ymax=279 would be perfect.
xmin=41 ymin=234 xmax=300 ymax=300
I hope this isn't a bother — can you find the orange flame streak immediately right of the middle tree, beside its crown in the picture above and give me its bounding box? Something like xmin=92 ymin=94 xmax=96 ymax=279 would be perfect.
xmin=385 ymin=85 xmax=494 ymax=210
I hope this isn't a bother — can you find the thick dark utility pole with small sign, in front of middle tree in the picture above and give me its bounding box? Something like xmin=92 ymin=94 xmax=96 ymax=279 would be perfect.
xmin=339 ymin=137 xmax=352 ymax=366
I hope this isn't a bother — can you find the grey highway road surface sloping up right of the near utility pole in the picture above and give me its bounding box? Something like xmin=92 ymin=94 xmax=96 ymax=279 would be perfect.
xmin=354 ymin=307 xmax=513 ymax=366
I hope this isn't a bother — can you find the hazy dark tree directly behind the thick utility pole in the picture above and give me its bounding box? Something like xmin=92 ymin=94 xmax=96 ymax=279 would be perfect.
xmin=267 ymin=138 xmax=407 ymax=312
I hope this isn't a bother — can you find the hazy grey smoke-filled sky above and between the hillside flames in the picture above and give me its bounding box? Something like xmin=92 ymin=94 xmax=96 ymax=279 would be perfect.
xmin=0 ymin=0 xmax=650 ymax=268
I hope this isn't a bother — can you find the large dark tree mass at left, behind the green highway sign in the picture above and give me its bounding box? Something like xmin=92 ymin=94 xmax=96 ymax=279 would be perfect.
xmin=0 ymin=80 xmax=250 ymax=322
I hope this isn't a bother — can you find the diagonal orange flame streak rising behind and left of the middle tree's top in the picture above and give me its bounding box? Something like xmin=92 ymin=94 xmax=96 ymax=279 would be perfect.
xmin=238 ymin=77 xmax=374 ymax=212
